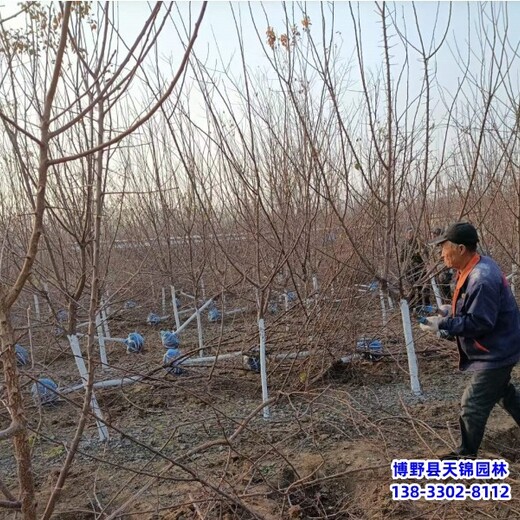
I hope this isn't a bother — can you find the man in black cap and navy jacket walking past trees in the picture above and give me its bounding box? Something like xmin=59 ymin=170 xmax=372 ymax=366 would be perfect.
xmin=421 ymin=222 xmax=520 ymax=458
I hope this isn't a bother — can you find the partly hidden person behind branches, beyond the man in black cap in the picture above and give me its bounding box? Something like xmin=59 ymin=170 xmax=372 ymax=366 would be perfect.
xmin=400 ymin=228 xmax=430 ymax=307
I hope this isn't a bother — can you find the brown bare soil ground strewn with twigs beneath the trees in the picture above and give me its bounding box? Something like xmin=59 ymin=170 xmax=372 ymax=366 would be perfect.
xmin=0 ymin=300 xmax=520 ymax=520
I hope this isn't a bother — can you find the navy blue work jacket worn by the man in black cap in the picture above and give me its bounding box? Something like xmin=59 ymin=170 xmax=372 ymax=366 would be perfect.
xmin=439 ymin=256 xmax=520 ymax=372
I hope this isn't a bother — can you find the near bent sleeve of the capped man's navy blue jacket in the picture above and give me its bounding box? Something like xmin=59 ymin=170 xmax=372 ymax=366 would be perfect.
xmin=439 ymin=280 xmax=500 ymax=338
